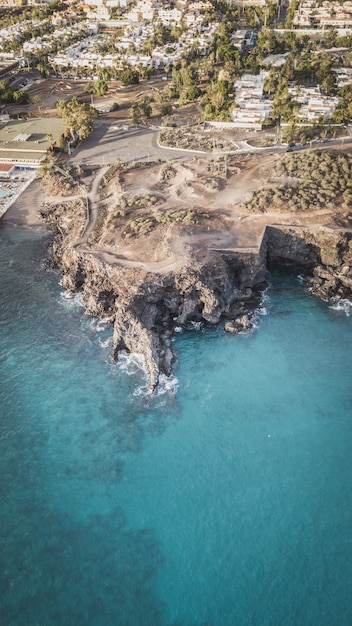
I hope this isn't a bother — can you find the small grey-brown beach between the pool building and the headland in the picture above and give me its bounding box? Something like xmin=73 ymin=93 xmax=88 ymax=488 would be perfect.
xmin=1 ymin=179 xmax=45 ymax=229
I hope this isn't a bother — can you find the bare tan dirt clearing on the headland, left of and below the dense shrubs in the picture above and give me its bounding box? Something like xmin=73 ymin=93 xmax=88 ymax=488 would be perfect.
xmin=77 ymin=155 xmax=348 ymax=273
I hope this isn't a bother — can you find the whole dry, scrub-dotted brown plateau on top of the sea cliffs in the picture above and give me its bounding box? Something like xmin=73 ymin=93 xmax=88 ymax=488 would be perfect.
xmin=38 ymin=151 xmax=352 ymax=272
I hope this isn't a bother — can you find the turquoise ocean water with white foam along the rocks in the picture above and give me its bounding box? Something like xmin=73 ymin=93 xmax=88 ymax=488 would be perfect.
xmin=0 ymin=225 xmax=352 ymax=626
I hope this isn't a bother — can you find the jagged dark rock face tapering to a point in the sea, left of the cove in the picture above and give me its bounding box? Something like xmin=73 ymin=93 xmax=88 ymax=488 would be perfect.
xmin=53 ymin=240 xmax=266 ymax=388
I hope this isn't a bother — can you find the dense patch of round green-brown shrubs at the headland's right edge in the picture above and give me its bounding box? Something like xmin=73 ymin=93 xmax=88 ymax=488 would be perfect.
xmin=245 ymin=152 xmax=352 ymax=213
